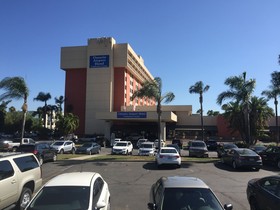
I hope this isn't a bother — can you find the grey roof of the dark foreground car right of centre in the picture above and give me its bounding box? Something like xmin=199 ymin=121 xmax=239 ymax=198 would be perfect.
xmin=161 ymin=176 xmax=209 ymax=189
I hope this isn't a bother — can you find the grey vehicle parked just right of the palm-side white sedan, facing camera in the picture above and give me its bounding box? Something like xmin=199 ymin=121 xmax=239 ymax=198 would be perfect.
xmin=188 ymin=140 xmax=209 ymax=157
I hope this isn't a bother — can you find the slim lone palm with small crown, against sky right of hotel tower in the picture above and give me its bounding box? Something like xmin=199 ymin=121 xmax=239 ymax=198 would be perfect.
xmin=189 ymin=81 xmax=210 ymax=141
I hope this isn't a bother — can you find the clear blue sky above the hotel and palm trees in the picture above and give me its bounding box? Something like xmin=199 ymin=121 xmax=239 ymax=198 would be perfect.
xmin=0 ymin=0 xmax=280 ymax=113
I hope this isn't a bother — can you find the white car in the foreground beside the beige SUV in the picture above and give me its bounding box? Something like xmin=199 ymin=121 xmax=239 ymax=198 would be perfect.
xmin=26 ymin=172 xmax=110 ymax=210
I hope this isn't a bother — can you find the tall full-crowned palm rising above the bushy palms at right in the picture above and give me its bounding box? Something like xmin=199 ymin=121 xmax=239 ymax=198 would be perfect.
xmin=217 ymin=72 xmax=256 ymax=142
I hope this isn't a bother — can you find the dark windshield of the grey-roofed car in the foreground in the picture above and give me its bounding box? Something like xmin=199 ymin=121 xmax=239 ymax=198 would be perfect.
xmin=161 ymin=188 xmax=223 ymax=210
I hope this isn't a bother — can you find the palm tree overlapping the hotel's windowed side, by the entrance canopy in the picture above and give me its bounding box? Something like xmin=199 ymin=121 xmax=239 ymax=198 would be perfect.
xmin=131 ymin=77 xmax=175 ymax=150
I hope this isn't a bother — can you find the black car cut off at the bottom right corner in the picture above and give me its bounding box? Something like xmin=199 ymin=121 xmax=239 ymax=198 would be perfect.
xmin=246 ymin=176 xmax=280 ymax=210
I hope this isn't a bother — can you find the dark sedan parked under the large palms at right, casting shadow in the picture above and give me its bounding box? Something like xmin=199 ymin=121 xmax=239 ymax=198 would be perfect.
xmin=221 ymin=148 xmax=262 ymax=171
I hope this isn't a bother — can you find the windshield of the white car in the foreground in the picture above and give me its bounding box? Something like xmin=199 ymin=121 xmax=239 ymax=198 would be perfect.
xmin=27 ymin=186 xmax=90 ymax=210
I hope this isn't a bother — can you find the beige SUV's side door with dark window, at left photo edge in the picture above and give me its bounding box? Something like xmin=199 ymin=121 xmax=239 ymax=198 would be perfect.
xmin=0 ymin=160 xmax=19 ymax=209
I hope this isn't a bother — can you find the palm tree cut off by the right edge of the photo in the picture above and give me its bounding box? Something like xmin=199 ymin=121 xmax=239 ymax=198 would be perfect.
xmin=262 ymin=71 xmax=280 ymax=144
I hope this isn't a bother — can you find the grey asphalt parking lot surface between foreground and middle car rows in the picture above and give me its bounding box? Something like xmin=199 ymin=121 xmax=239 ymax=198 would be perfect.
xmin=42 ymin=148 xmax=279 ymax=210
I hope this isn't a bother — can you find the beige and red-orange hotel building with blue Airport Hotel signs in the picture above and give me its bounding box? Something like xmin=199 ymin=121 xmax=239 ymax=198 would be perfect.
xmin=61 ymin=37 xmax=276 ymax=143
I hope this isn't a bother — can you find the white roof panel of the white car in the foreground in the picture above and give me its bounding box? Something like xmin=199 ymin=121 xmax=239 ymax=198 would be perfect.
xmin=45 ymin=172 xmax=99 ymax=187
